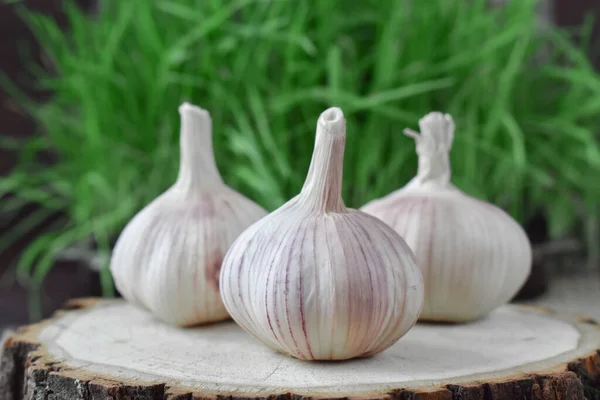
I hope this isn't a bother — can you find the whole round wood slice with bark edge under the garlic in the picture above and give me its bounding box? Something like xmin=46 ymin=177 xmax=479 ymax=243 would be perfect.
xmin=0 ymin=299 xmax=600 ymax=400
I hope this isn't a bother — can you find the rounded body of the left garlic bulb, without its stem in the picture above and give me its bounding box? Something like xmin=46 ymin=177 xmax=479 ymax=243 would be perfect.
xmin=111 ymin=190 xmax=264 ymax=326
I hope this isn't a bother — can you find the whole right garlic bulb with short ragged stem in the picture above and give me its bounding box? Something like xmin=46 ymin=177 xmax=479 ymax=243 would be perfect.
xmin=361 ymin=112 xmax=532 ymax=322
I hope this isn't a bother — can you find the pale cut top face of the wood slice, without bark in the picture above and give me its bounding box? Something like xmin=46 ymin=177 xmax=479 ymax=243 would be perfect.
xmin=38 ymin=302 xmax=581 ymax=388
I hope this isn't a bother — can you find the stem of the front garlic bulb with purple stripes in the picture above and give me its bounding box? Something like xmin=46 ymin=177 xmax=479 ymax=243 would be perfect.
xmin=300 ymin=107 xmax=346 ymax=213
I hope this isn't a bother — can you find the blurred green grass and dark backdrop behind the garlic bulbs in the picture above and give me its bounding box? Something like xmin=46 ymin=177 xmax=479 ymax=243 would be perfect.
xmin=0 ymin=0 xmax=600 ymax=330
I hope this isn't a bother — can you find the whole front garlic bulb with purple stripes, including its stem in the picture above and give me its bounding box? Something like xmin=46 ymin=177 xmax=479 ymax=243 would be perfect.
xmin=221 ymin=108 xmax=423 ymax=360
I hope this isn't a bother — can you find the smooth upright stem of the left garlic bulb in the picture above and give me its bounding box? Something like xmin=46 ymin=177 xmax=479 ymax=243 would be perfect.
xmin=176 ymin=103 xmax=223 ymax=190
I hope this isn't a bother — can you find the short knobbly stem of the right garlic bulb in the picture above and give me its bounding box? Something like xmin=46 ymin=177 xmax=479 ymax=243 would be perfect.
xmin=404 ymin=112 xmax=454 ymax=186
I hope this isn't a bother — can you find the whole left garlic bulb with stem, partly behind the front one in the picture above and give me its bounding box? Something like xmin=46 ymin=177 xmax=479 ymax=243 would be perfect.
xmin=110 ymin=103 xmax=266 ymax=326
